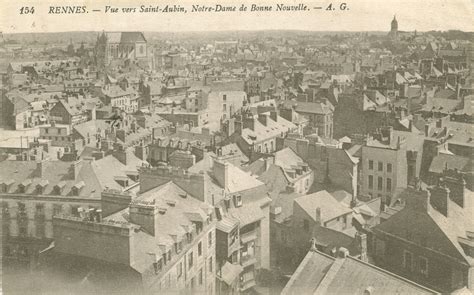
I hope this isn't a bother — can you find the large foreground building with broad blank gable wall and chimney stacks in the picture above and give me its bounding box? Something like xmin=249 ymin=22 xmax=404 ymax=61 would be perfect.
xmin=45 ymin=169 xmax=216 ymax=294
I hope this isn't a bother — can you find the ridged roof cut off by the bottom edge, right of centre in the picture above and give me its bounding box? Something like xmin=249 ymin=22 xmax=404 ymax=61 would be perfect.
xmin=281 ymin=250 xmax=437 ymax=295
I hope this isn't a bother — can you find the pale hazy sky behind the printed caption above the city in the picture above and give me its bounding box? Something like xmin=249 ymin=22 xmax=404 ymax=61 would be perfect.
xmin=0 ymin=0 xmax=474 ymax=33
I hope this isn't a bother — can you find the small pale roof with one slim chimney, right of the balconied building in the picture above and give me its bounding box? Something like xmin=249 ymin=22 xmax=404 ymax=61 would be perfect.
xmin=295 ymin=191 xmax=352 ymax=223
